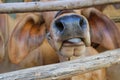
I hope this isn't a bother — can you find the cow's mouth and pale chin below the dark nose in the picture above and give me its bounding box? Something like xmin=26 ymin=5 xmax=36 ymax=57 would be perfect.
xmin=59 ymin=38 xmax=87 ymax=57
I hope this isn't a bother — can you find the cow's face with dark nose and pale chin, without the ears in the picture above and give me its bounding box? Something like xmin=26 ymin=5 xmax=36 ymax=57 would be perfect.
xmin=44 ymin=10 xmax=90 ymax=57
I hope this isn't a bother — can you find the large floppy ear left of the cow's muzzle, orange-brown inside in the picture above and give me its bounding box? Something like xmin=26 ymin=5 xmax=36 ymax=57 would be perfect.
xmin=8 ymin=14 xmax=45 ymax=64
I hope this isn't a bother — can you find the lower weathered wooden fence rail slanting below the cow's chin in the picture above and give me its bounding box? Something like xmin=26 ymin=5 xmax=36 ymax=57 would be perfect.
xmin=0 ymin=49 xmax=120 ymax=80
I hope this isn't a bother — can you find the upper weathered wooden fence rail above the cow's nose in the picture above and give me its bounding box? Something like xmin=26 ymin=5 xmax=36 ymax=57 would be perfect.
xmin=0 ymin=0 xmax=120 ymax=13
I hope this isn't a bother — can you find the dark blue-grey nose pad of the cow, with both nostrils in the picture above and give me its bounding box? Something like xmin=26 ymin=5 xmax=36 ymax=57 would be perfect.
xmin=53 ymin=15 xmax=87 ymax=39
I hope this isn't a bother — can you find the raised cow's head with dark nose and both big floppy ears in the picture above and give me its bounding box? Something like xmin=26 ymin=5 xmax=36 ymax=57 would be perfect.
xmin=9 ymin=8 xmax=120 ymax=63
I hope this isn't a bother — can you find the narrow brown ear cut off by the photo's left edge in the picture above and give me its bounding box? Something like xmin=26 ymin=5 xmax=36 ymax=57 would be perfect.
xmin=0 ymin=14 xmax=8 ymax=62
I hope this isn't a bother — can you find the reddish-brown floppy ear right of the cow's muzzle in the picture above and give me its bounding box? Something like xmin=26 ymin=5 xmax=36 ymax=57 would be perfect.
xmin=82 ymin=8 xmax=120 ymax=49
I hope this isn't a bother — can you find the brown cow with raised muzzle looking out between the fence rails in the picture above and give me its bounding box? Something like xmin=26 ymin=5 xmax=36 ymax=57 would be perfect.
xmin=0 ymin=0 xmax=119 ymax=80
